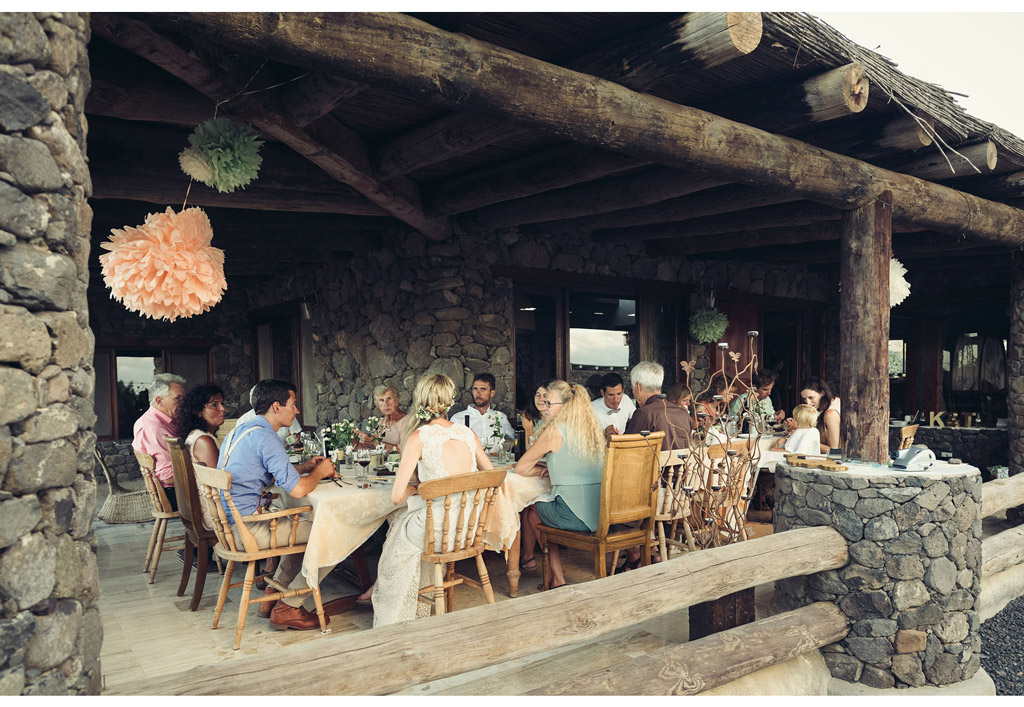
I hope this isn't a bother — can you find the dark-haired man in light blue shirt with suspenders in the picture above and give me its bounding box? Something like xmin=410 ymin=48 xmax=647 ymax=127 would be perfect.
xmin=217 ymin=380 xmax=335 ymax=630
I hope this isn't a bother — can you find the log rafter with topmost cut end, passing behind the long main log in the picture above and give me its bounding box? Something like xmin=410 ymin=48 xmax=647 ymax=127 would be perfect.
xmin=374 ymin=12 xmax=761 ymax=179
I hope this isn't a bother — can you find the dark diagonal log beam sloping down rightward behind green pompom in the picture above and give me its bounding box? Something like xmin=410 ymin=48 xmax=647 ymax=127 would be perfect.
xmin=92 ymin=13 xmax=452 ymax=240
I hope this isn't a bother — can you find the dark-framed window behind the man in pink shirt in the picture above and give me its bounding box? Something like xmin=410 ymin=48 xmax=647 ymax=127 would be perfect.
xmin=92 ymin=338 xmax=213 ymax=440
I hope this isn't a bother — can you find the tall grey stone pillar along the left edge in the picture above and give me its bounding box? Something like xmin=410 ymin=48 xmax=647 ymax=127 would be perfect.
xmin=0 ymin=12 xmax=102 ymax=695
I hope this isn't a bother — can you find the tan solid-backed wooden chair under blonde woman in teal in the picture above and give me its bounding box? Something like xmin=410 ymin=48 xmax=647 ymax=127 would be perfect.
xmin=537 ymin=432 xmax=665 ymax=589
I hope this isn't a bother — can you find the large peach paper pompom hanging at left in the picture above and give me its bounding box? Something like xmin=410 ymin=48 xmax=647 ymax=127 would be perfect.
xmin=99 ymin=207 xmax=227 ymax=322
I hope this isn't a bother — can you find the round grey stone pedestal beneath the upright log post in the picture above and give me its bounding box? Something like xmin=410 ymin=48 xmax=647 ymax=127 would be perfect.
xmin=774 ymin=464 xmax=981 ymax=688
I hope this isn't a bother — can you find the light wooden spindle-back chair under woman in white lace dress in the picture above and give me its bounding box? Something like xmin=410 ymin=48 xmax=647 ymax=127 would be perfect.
xmin=418 ymin=469 xmax=505 ymax=614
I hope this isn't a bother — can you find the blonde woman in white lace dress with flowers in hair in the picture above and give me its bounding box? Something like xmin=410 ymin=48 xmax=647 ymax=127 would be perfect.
xmin=373 ymin=373 xmax=494 ymax=628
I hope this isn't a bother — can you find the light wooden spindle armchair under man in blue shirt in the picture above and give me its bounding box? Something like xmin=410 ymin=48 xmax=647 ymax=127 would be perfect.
xmin=194 ymin=464 xmax=330 ymax=651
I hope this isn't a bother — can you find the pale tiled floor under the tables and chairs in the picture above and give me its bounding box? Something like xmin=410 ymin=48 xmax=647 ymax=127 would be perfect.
xmin=93 ymin=479 xmax=771 ymax=695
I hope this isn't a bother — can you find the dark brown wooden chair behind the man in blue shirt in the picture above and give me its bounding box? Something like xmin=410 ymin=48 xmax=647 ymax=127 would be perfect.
xmin=164 ymin=436 xmax=220 ymax=612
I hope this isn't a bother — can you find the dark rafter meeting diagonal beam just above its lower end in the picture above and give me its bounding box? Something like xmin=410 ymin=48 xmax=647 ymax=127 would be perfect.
xmin=424 ymin=144 xmax=645 ymax=214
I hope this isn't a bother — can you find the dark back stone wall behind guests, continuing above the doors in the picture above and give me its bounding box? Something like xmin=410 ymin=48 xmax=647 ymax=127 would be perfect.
xmin=222 ymin=230 xmax=827 ymax=420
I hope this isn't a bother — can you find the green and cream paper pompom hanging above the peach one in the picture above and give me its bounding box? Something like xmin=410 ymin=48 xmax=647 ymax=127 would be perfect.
xmin=178 ymin=118 xmax=263 ymax=193
